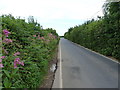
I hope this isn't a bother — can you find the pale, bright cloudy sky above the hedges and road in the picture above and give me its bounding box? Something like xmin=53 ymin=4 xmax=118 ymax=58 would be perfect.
xmin=0 ymin=0 xmax=105 ymax=36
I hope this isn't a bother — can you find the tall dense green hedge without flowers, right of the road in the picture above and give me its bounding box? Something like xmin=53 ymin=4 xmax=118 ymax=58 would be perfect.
xmin=64 ymin=2 xmax=120 ymax=60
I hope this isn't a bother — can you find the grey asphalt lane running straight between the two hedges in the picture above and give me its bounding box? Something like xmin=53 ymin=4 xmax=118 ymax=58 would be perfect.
xmin=54 ymin=38 xmax=118 ymax=88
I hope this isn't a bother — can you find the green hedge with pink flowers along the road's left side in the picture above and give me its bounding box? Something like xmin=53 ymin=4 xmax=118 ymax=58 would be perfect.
xmin=0 ymin=15 xmax=59 ymax=88
